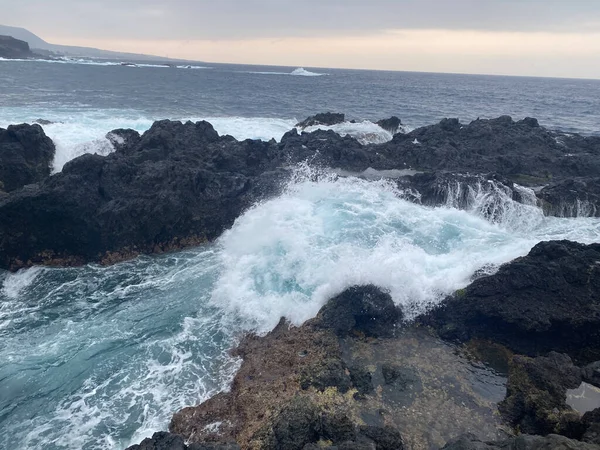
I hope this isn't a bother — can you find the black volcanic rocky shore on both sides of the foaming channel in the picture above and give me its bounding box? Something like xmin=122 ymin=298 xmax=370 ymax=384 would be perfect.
xmin=0 ymin=114 xmax=600 ymax=450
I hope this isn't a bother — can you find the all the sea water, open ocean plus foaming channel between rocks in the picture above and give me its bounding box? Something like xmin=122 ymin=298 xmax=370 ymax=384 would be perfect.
xmin=0 ymin=60 xmax=600 ymax=450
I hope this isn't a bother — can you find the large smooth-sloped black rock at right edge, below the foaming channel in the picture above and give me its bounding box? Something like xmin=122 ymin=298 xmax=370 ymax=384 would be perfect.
xmin=421 ymin=241 xmax=600 ymax=362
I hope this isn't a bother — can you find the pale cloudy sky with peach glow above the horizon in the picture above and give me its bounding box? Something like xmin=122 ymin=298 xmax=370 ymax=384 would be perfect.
xmin=0 ymin=0 xmax=600 ymax=78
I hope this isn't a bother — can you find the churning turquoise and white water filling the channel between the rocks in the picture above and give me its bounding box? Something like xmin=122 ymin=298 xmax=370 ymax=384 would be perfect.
xmin=0 ymin=167 xmax=600 ymax=450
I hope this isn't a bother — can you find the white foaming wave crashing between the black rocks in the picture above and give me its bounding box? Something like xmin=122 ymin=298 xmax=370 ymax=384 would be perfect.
xmin=213 ymin=167 xmax=600 ymax=332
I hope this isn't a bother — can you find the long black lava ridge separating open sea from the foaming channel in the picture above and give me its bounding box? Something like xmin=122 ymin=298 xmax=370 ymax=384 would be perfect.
xmin=0 ymin=117 xmax=600 ymax=270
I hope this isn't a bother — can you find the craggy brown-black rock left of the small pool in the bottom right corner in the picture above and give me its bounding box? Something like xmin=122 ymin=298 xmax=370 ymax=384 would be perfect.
xmin=499 ymin=352 xmax=587 ymax=439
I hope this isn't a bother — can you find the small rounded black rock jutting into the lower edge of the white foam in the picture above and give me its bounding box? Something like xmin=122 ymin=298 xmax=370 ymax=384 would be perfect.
xmin=316 ymin=285 xmax=402 ymax=337
